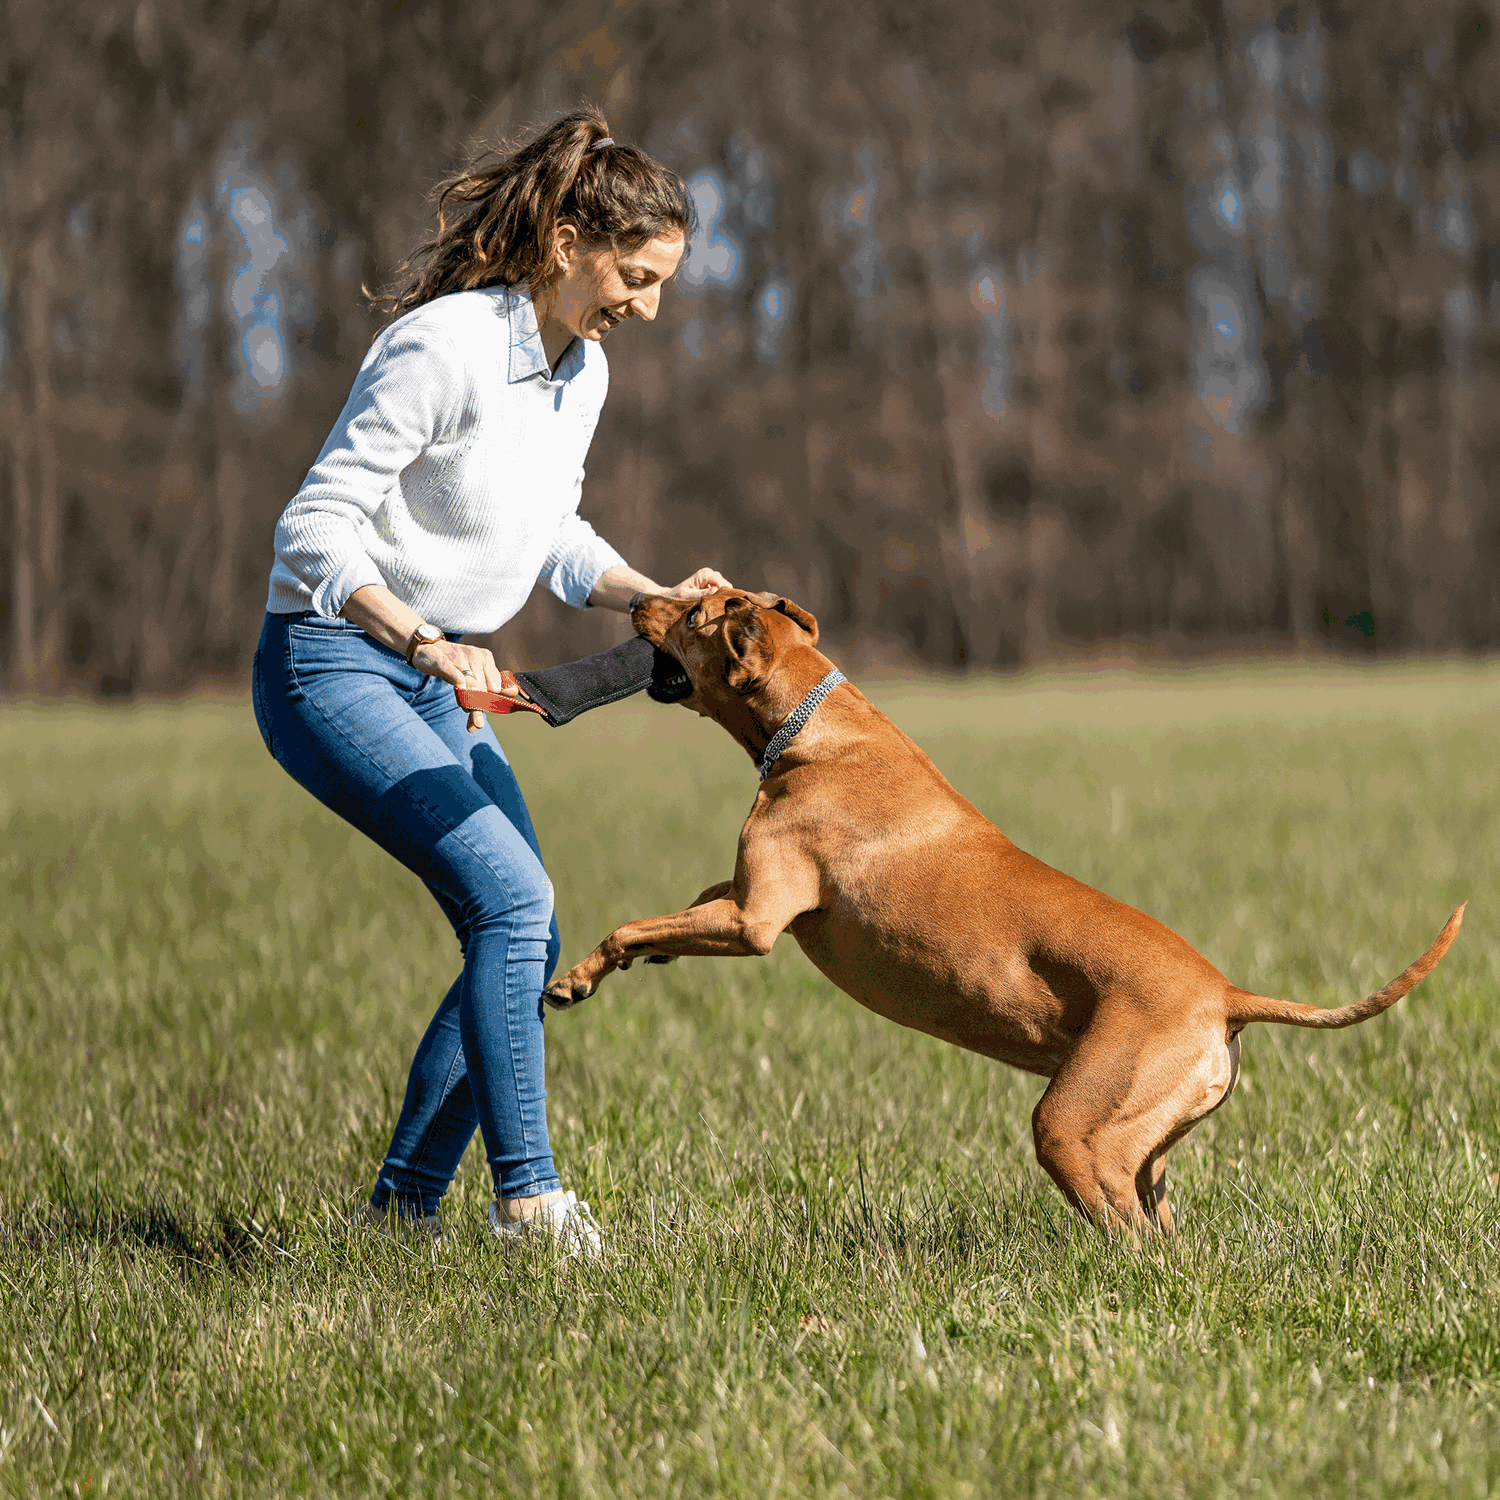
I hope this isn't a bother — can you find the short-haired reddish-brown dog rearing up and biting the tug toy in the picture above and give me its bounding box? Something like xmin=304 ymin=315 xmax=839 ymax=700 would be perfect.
xmin=546 ymin=590 xmax=1464 ymax=1233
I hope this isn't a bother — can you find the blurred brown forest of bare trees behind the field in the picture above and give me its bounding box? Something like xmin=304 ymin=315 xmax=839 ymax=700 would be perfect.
xmin=0 ymin=0 xmax=1500 ymax=695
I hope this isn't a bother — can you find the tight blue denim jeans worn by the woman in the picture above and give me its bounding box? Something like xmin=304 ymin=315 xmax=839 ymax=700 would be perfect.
xmin=254 ymin=615 xmax=561 ymax=1214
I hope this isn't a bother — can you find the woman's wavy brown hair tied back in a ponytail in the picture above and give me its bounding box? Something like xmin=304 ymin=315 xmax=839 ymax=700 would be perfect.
xmin=371 ymin=105 xmax=698 ymax=318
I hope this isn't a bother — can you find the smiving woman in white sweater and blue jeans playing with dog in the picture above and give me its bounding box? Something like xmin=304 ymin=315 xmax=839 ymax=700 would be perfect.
xmin=254 ymin=110 xmax=726 ymax=1253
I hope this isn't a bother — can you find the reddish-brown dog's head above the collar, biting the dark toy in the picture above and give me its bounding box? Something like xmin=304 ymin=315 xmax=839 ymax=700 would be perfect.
xmin=630 ymin=588 xmax=818 ymax=713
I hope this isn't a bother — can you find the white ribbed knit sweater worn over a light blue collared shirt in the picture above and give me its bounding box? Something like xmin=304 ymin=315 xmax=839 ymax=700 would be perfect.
xmin=266 ymin=288 xmax=624 ymax=635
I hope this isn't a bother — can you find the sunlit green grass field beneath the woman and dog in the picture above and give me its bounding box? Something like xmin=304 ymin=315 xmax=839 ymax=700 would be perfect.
xmin=0 ymin=666 xmax=1500 ymax=1500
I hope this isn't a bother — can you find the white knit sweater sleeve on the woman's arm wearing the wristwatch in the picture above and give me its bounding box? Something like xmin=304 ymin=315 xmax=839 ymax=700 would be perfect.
xmin=267 ymin=327 xmax=465 ymax=620
